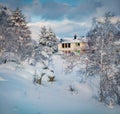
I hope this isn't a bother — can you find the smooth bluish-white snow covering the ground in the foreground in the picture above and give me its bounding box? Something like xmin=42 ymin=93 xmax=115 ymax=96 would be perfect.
xmin=0 ymin=55 xmax=120 ymax=114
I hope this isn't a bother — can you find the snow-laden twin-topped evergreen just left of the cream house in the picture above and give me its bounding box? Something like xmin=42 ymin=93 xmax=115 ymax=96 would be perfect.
xmin=29 ymin=26 xmax=58 ymax=65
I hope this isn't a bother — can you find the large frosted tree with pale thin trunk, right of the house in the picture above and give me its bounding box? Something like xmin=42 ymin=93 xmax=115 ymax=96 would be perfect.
xmin=88 ymin=12 xmax=120 ymax=105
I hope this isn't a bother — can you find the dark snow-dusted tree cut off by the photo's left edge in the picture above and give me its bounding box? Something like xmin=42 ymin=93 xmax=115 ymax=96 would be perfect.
xmin=0 ymin=5 xmax=19 ymax=63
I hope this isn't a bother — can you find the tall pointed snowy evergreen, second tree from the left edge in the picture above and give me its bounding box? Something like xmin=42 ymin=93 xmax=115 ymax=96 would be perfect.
xmin=11 ymin=8 xmax=32 ymax=59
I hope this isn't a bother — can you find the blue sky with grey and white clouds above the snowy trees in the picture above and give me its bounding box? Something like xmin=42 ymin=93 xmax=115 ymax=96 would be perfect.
xmin=0 ymin=0 xmax=120 ymax=38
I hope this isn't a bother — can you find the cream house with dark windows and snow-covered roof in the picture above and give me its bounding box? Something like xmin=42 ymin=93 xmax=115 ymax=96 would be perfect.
xmin=58 ymin=38 xmax=89 ymax=53
